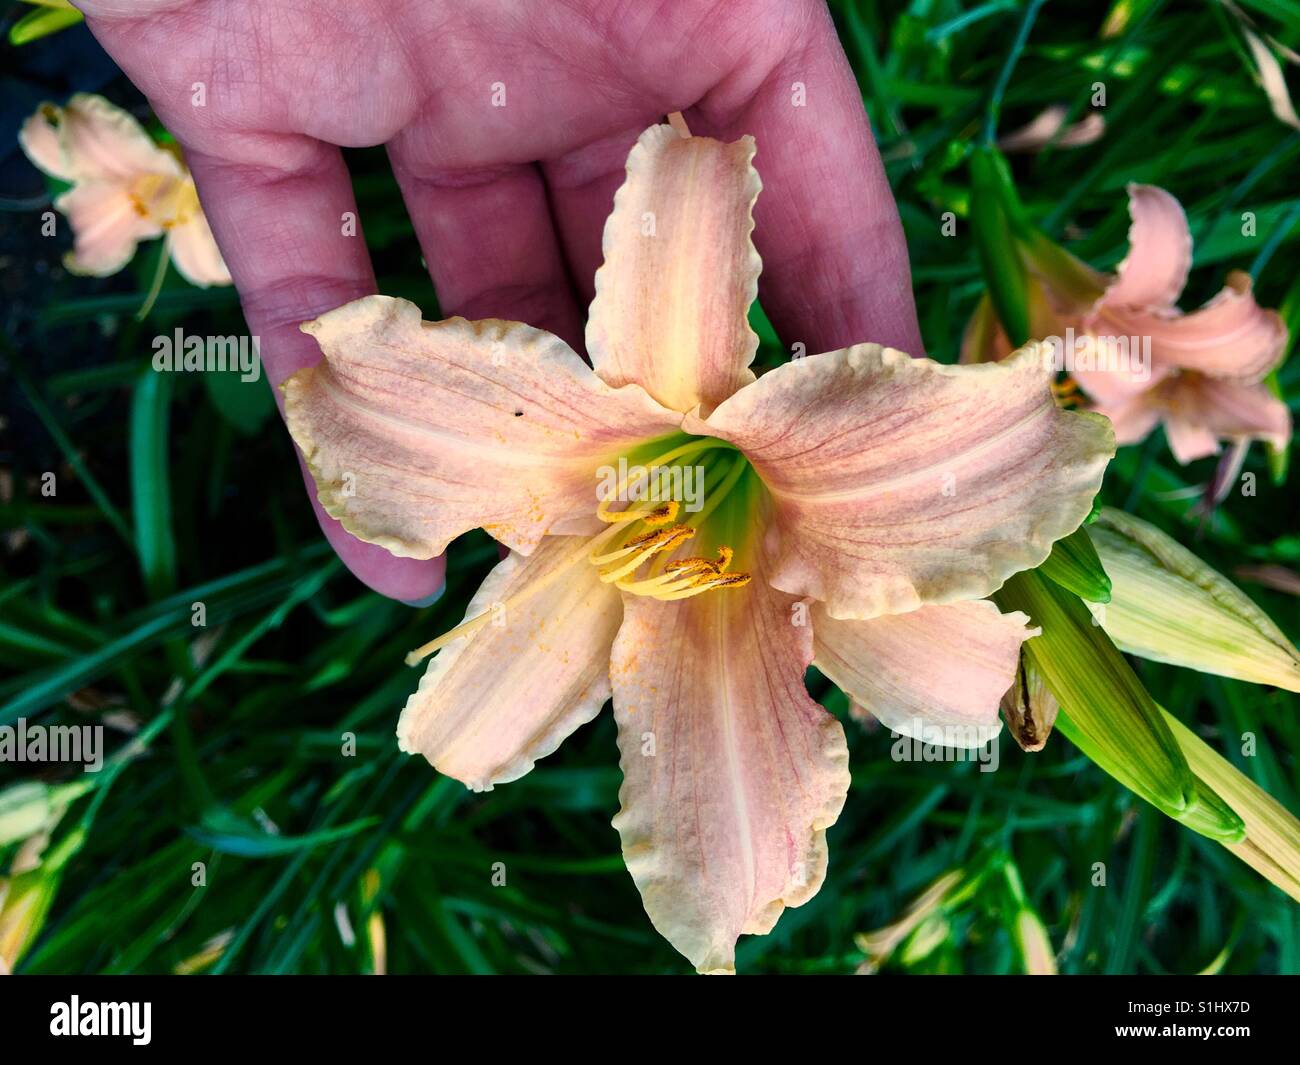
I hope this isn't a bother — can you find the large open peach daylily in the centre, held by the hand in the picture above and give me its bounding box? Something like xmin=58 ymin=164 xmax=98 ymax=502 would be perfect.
xmin=285 ymin=118 xmax=1114 ymax=971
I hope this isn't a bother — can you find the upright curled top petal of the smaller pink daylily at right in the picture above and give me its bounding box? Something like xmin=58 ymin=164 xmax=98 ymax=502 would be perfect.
xmin=1102 ymin=185 xmax=1192 ymax=308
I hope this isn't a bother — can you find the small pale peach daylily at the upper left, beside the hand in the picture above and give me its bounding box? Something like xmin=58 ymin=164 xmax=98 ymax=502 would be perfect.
xmin=18 ymin=92 xmax=230 ymax=287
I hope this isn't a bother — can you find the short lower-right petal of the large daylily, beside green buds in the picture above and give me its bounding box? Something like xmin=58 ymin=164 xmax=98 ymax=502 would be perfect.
xmin=813 ymin=599 xmax=1036 ymax=748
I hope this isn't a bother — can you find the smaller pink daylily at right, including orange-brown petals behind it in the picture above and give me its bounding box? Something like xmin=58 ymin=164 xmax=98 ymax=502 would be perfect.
xmin=962 ymin=185 xmax=1291 ymax=464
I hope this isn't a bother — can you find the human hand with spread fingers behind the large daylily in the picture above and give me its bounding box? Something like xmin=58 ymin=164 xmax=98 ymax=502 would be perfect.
xmin=77 ymin=0 xmax=922 ymax=601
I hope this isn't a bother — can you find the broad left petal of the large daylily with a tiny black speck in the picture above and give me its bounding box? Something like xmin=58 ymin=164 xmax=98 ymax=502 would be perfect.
xmin=285 ymin=296 xmax=680 ymax=558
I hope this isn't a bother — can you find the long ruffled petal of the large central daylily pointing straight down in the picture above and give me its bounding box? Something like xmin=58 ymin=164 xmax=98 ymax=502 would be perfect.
xmin=610 ymin=548 xmax=849 ymax=973
